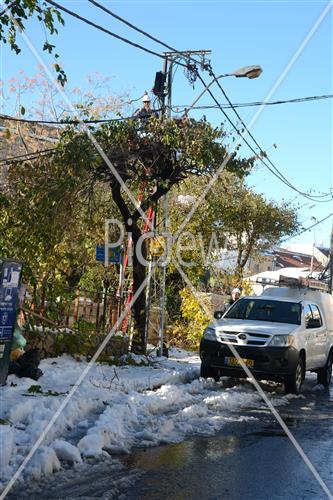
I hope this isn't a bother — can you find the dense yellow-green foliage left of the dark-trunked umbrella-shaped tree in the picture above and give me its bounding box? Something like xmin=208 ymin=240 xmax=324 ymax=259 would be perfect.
xmin=0 ymin=141 xmax=122 ymax=314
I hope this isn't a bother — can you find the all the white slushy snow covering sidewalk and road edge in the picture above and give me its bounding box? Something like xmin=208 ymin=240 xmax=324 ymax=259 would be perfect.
xmin=0 ymin=349 xmax=288 ymax=486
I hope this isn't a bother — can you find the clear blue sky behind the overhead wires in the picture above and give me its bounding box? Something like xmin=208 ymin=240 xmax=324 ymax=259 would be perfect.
xmin=1 ymin=0 xmax=333 ymax=245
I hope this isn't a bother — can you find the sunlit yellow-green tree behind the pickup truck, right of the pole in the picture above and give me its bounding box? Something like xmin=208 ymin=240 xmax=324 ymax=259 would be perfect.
xmin=169 ymin=171 xmax=299 ymax=287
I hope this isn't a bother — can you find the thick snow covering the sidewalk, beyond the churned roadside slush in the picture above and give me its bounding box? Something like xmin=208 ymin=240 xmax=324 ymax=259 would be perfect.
xmin=0 ymin=350 xmax=199 ymax=486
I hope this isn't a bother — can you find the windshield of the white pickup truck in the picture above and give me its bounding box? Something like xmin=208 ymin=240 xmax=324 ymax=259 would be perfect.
xmin=224 ymin=299 xmax=302 ymax=325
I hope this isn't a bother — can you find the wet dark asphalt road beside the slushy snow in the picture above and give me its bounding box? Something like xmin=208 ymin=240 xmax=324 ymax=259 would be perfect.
xmin=8 ymin=378 xmax=333 ymax=500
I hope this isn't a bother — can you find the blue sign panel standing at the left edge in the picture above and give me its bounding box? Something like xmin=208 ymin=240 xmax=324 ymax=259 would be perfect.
xmin=0 ymin=260 xmax=22 ymax=385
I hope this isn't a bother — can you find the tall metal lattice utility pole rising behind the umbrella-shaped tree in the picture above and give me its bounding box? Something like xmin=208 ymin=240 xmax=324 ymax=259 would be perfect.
xmin=155 ymin=50 xmax=211 ymax=356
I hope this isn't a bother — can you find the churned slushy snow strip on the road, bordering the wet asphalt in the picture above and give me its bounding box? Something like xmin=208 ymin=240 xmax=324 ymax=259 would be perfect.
xmin=78 ymin=379 xmax=287 ymax=457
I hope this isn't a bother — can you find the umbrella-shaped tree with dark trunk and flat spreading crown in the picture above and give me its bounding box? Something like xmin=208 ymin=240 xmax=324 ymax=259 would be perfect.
xmin=54 ymin=118 xmax=249 ymax=352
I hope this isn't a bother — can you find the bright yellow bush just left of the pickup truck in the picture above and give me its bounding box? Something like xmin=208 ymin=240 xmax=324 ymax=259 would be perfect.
xmin=171 ymin=288 xmax=211 ymax=349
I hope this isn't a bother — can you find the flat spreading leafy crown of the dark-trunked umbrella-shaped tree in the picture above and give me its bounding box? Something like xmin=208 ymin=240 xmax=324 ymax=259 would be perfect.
xmin=61 ymin=118 xmax=252 ymax=203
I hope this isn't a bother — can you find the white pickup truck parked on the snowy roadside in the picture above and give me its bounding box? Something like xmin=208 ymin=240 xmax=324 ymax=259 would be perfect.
xmin=200 ymin=287 xmax=333 ymax=394
